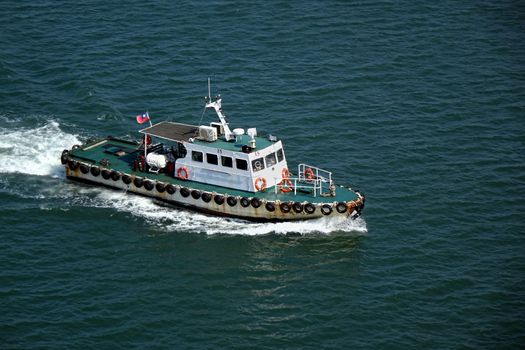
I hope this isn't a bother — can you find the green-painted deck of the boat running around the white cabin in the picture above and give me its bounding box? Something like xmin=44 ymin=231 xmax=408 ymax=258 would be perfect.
xmin=70 ymin=138 xmax=359 ymax=203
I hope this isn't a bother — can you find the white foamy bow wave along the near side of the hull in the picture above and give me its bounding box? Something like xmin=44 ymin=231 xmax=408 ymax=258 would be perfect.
xmin=92 ymin=191 xmax=368 ymax=236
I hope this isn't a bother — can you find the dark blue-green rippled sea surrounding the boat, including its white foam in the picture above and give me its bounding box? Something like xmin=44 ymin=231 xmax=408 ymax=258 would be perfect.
xmin=0 ymin=0 xmax=525 ymax=349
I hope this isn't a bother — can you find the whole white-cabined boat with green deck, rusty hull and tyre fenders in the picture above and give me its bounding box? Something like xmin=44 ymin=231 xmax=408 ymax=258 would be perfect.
xmin=61 ymin=80 xmax=365 ymax=221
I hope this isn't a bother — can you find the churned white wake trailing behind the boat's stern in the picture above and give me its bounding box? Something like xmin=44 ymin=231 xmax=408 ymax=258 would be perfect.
xmin=0 ymin=121 xmax=80 ymax=177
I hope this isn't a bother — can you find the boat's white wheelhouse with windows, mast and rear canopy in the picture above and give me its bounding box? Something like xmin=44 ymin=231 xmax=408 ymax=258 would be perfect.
xmin=140 ymin=95 xmax=288 ymax=192
